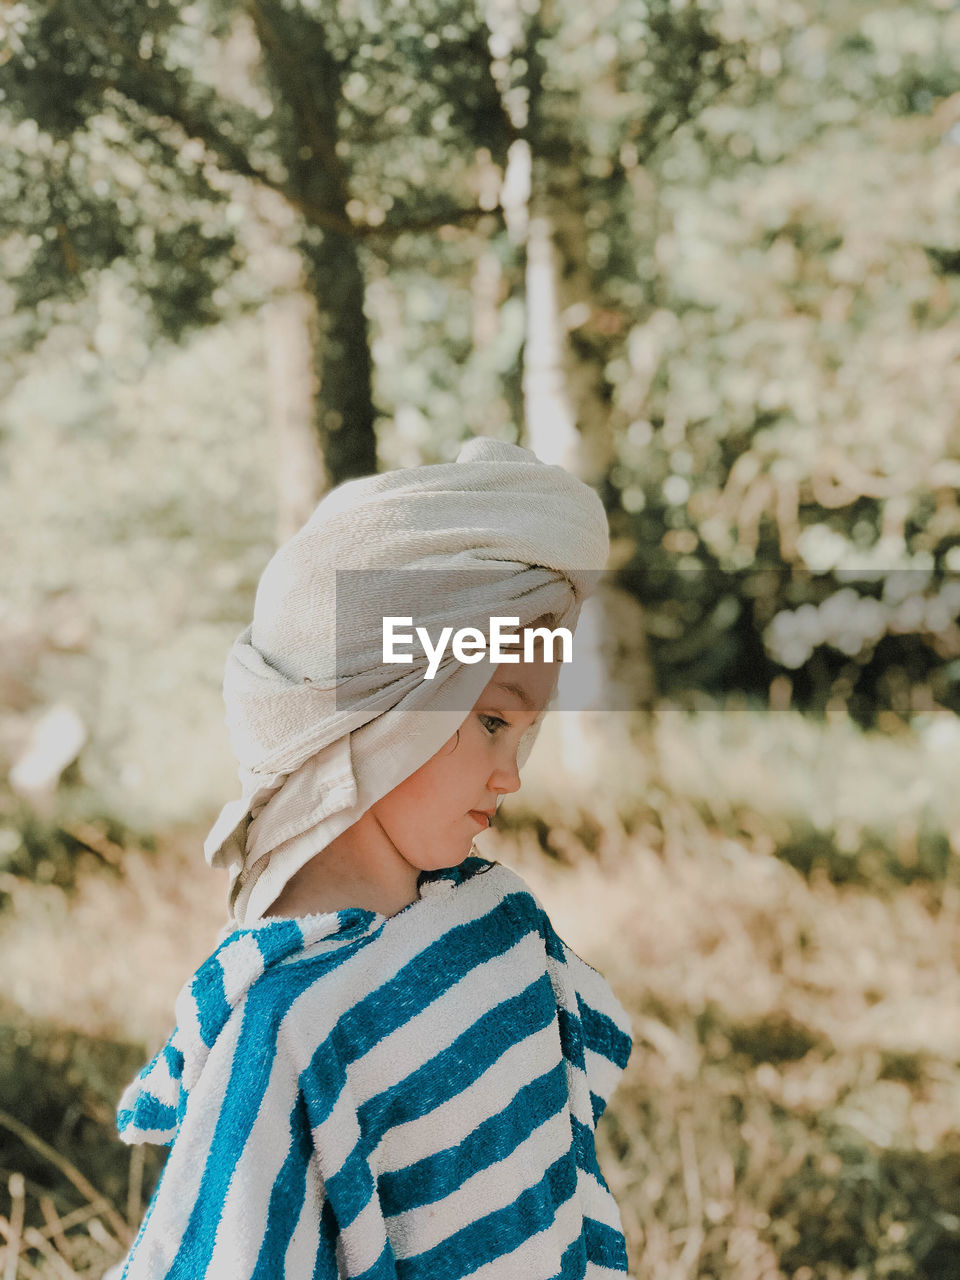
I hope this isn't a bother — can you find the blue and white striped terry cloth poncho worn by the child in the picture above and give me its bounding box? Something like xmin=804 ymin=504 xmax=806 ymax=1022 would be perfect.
xmin=118 ymin=856 xmax=631 ymax=1280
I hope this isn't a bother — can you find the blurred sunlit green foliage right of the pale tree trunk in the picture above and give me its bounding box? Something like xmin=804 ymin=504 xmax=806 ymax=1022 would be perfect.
xmin=591 ymin=5 xmax=960 ymax=719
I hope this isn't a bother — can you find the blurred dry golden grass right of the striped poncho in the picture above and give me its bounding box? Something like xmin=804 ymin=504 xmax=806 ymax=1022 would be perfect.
xmin=506 ymin=812 xmax=960 ymax=1280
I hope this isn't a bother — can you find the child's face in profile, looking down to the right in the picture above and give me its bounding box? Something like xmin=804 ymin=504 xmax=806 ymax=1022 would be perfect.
xmin=371 ymin=658 xmax=558 ymax=870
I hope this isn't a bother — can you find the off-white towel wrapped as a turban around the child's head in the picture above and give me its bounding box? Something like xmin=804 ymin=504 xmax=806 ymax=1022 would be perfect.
xmin=204 ymin=436 xmax=609 ymax=927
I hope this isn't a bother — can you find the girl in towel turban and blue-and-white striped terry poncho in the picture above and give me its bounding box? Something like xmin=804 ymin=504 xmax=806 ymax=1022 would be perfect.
xmin=118 ymin=438 xmax=631 ymax=1280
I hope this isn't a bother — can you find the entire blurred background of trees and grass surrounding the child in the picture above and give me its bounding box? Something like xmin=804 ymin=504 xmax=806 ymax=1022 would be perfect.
xmin=0 ymin=0 xmax=960 ymax=1280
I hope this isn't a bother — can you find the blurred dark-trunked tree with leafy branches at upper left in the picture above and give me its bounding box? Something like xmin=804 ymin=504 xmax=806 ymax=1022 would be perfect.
xmin=0 ymin=0 xmax=511 ymax=494
